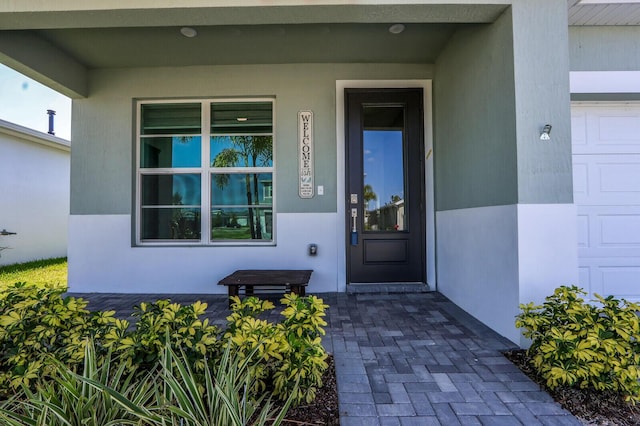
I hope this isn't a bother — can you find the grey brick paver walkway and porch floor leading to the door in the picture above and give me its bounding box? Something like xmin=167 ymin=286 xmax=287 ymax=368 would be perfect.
xmin=67 ymin=293 xmax=581 ymax=426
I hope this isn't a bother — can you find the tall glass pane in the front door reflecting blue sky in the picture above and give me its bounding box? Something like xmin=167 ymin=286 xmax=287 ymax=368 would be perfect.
xmin=362 ymin=106 xmax=407 ymax=232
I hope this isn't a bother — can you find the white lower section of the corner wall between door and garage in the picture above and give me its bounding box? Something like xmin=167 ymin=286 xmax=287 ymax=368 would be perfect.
xmin=436 ymin=204 xmax=578 ymax=347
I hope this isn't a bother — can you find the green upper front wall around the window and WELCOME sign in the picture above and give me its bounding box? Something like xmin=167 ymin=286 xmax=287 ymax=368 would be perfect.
xmin=71 ymin=64 xmax=433 ymax=214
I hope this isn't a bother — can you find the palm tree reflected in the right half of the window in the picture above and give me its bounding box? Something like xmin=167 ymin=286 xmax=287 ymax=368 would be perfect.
xmin=211 ymin=136 xmax=273 ymax=240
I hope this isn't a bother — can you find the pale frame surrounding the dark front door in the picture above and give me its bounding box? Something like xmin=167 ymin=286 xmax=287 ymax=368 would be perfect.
xmin=336 ymin=80 xmax=437 ymax=292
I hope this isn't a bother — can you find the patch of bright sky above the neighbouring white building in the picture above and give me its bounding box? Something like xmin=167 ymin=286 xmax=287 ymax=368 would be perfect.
xmin=0 ymin=64 xmax=71 ymax=140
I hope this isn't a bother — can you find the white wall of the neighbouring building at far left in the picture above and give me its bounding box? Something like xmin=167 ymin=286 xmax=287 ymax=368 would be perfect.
xmin=0 ymin=120 xmax=70 ymax=265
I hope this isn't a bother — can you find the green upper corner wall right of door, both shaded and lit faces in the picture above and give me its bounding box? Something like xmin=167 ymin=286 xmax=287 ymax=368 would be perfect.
xmin=434 ymin=0 xmax=573 ymax=211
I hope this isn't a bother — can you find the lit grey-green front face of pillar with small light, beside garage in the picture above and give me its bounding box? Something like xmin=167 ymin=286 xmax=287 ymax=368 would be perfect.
xmin=512 ymin=0 xmax=573 ymax=204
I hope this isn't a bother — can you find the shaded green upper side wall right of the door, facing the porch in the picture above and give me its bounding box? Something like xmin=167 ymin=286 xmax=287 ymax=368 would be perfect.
xmin=434 ymin=12 xmax=517 ymax=210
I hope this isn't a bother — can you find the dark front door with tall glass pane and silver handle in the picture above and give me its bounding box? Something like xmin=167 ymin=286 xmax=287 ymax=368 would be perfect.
xmin=345 ymin=89 xmax=425 ymax=283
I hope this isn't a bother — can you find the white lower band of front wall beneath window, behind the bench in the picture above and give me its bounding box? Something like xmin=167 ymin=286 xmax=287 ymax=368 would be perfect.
xmin=69 ymin=213 xmax=345 ymax=294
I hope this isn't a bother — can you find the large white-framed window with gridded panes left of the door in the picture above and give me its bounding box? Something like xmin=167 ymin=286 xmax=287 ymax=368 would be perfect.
xmin=136 ymin=99 xmax=274 ymax=244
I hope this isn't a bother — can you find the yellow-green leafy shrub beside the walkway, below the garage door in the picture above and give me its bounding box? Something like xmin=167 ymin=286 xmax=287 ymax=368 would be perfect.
xmin=516 ymin=286 xmax=640 ymax=403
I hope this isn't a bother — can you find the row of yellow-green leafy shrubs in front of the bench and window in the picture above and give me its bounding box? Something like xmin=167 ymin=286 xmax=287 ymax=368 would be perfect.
xmin=0 ymin=283 xmax=327 ymax=404
